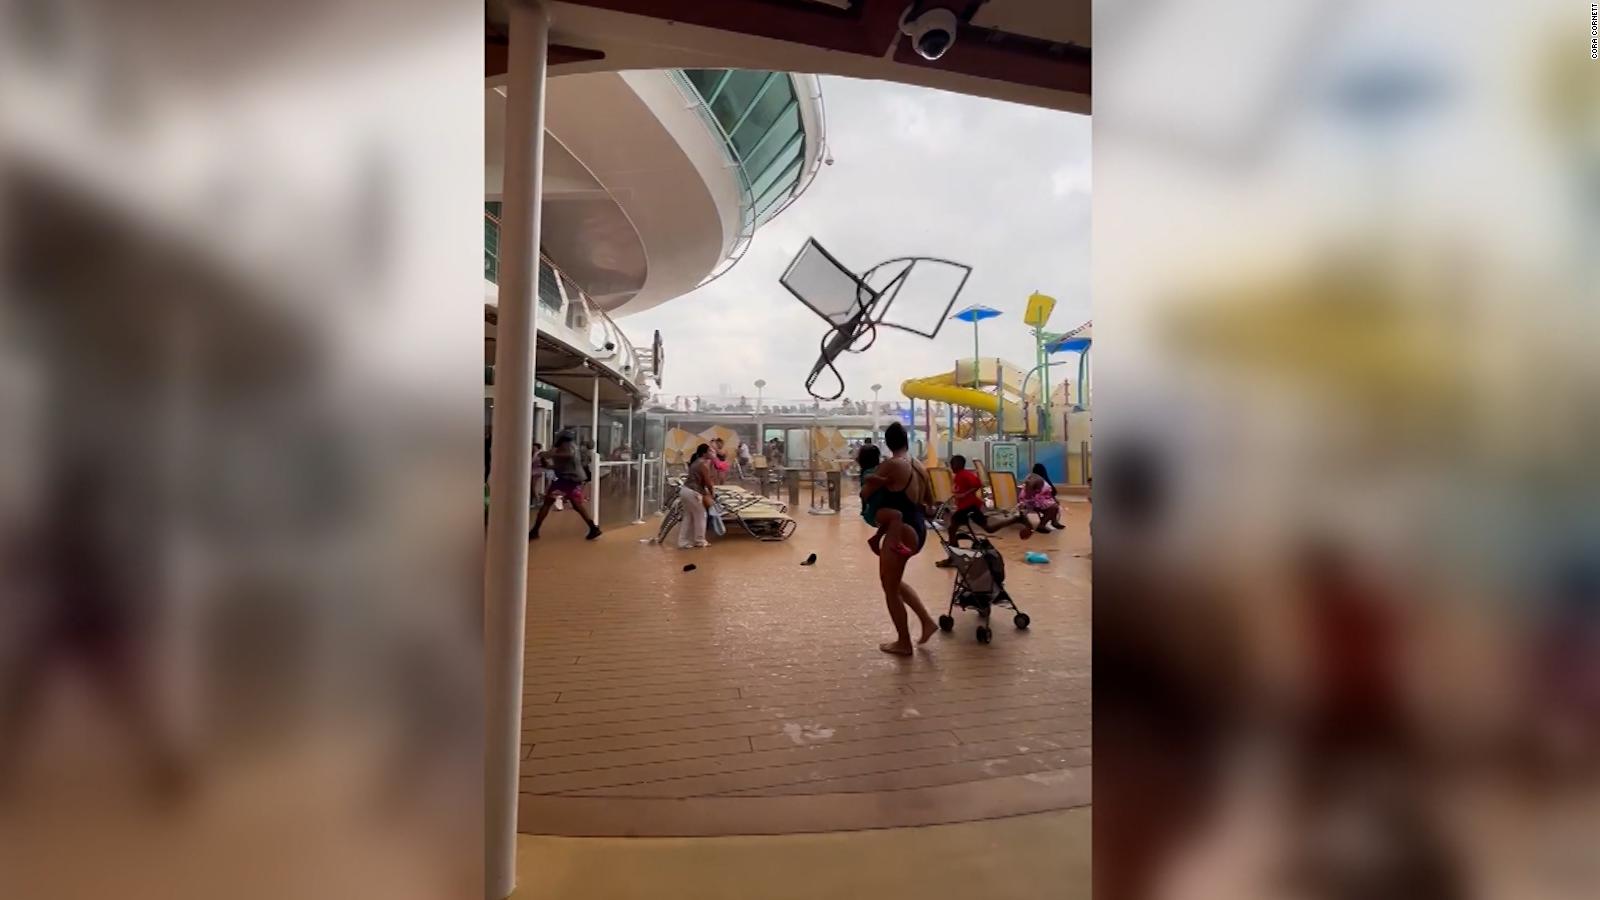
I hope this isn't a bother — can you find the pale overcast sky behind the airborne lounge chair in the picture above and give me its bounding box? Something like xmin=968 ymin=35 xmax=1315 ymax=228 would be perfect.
xmin=619 ymin=77 xmax=1090 ymax=400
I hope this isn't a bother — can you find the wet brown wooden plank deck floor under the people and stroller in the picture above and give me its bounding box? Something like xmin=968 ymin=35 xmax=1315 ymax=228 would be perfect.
xmin=520 ymin=501 xmax=1090 ymax=836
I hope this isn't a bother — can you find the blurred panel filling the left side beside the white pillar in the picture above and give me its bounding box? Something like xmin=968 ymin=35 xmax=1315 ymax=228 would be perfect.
xmin=0 ymin=0 xmax=483 ymax=898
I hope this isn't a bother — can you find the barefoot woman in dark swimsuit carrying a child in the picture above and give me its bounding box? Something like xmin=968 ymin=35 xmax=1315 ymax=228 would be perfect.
xmin=861 ymin=423 xmax=939 ymax=657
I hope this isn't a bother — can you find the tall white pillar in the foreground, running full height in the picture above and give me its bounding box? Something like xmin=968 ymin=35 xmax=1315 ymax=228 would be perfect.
xmin=483 ymin=0 xmax=550 ymax=900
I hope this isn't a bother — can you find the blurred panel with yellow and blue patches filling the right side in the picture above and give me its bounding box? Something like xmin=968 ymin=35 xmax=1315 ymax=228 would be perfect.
xmin=1094 ymin=0 xmax=1600 ymax=898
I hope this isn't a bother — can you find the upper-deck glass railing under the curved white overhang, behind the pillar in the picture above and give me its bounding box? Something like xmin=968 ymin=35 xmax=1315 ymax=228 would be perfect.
xmin=483 ymin=203 xmax=654 ymax=386
